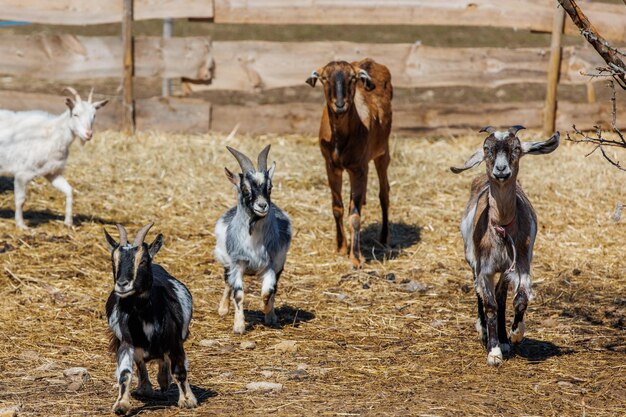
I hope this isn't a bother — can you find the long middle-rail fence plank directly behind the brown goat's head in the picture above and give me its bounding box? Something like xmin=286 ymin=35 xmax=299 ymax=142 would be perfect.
xmin=183 ymin=41 xmax=602 ymax=91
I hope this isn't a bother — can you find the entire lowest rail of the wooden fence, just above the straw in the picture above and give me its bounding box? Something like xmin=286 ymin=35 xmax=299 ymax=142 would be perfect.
xmin=0 ymin=91 xmax=626 ymax=136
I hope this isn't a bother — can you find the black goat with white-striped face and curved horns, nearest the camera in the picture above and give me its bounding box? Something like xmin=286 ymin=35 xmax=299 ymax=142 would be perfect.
xmin=104 ymin=223 xmax=197 ymax=414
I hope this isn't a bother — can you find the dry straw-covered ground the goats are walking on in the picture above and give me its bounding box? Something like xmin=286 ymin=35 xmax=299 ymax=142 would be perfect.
xmin=0 ymin=132 xmax=626 ymax=416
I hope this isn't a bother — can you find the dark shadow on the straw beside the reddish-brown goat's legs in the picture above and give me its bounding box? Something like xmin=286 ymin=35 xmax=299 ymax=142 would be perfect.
xmin=361 ymin=223 xmax=421 ymax=262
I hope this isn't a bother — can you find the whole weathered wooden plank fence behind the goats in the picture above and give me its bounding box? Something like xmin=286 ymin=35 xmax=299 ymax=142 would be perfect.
xmin=0 ymin=0 xmax=626 ymax=133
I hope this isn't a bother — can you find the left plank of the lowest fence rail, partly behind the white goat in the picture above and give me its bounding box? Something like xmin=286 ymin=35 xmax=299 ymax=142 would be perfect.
xmin=0 ymin=91 xmax=211 ymax=133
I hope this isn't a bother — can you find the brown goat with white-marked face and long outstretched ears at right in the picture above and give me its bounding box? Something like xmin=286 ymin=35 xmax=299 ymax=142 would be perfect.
xmin=450 ymin=126 xmax=560 ymax=366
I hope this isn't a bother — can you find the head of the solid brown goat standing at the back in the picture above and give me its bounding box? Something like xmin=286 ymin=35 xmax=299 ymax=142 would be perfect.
xmin=306 ymin=61 xmax=376 ymax=115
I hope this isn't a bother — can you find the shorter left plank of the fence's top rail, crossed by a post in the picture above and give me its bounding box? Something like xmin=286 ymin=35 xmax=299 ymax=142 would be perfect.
xmin=0 ymin=0 xmax=213 ymax=25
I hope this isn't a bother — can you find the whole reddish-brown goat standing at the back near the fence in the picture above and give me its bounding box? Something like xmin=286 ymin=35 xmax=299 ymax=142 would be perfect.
xmin=306 ymin=58 xmax=393 ymax=268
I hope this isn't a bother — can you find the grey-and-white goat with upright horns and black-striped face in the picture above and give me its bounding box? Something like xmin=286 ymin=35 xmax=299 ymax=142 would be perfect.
xmin=215 ymin=145 xmax=291 ymax=334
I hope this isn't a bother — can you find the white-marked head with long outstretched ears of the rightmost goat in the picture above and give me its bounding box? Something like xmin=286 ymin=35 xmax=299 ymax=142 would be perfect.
xmin=450 ymin=125 xmax=561 ymax=184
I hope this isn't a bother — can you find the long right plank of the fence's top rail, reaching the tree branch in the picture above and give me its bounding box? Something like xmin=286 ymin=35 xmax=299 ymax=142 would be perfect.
xmin=215 ymin=0 xmax=626 ymax=41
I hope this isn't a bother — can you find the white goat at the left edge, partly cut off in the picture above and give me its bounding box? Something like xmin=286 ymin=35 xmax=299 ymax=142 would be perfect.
xmin=0 ymin=87 xmax=108 ymax=229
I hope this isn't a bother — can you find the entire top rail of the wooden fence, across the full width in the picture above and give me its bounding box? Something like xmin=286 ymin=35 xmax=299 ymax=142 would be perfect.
xmin=0 ymin=0 xmax=626 ymax=42
